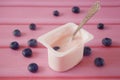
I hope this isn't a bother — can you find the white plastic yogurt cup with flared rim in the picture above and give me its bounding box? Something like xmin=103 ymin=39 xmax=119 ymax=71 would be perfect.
xmin=38 ymin=23 xmax=93 ymax=72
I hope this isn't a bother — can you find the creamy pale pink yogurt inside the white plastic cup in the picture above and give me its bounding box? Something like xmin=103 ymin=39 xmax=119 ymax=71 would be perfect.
xmin=51 ymin=34 xmax=82 ymax=52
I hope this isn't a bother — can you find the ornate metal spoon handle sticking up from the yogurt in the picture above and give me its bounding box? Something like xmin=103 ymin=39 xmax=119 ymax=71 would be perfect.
xmin=72 ymin=1 xmax=100 ymax=39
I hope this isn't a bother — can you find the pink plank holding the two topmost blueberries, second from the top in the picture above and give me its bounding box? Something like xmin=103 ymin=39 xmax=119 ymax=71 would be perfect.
xmin=0 ymin=7 xmax=120 ymax=24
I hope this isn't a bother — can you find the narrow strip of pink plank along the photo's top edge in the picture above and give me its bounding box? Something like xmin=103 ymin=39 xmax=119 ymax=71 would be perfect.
xmin=0 ymin=0 xmax=120 ymax=7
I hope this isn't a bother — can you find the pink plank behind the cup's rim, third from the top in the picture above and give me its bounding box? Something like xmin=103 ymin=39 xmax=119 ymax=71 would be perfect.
xmin=0 ymin=24 xmax=120 ymax=48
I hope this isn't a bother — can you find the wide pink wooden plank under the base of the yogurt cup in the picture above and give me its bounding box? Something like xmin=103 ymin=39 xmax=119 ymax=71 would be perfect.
xmin=0 ymin=48 xmax=120 ymax=79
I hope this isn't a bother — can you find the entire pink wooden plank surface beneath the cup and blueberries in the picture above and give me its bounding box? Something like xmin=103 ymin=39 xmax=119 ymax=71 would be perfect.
xmin=0 ymin=0 xmax=120 ymax=80
